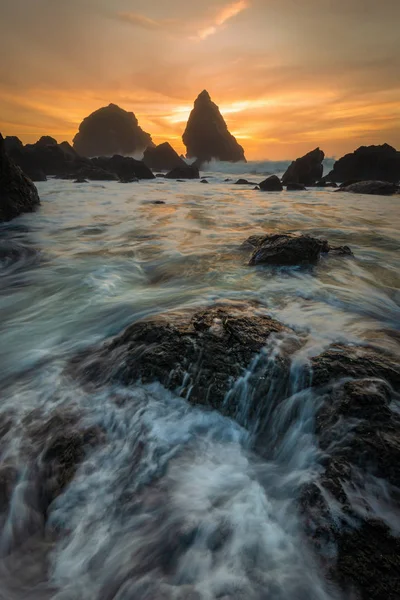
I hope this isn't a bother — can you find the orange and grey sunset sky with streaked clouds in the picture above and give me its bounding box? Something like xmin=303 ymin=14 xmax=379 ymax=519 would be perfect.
xmin=0 ymin=0 xmax=400 ymax=160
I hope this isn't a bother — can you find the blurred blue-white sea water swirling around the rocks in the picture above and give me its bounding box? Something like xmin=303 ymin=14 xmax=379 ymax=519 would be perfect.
xmin=0 ymin=163 xmax=400 ymax=600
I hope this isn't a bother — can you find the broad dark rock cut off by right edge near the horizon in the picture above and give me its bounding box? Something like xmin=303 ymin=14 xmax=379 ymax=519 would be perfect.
xmin=324 ymin=144 xmax=400 ymax=183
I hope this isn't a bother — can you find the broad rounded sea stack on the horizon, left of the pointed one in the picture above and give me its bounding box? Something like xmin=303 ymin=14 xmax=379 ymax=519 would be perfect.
xmin=73 ymin=104 xmax=154 ymax=157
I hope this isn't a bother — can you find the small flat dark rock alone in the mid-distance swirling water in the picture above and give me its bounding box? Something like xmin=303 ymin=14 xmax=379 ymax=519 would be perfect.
xmin=244 ymin=233 xmax=352 ymax=266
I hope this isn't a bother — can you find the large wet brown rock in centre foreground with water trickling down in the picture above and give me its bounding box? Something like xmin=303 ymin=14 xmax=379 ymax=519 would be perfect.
xmin=70 ymin=303 xmax=294 ymax=415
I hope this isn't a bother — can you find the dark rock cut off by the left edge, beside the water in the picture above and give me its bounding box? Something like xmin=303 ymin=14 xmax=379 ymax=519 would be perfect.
xmin=0 ymin=134 xmax=40 ymax=222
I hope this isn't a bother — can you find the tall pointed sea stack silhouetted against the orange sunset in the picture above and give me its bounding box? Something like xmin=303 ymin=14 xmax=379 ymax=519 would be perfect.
xmin=182 ymin=90 xmax=246 ymax=163
